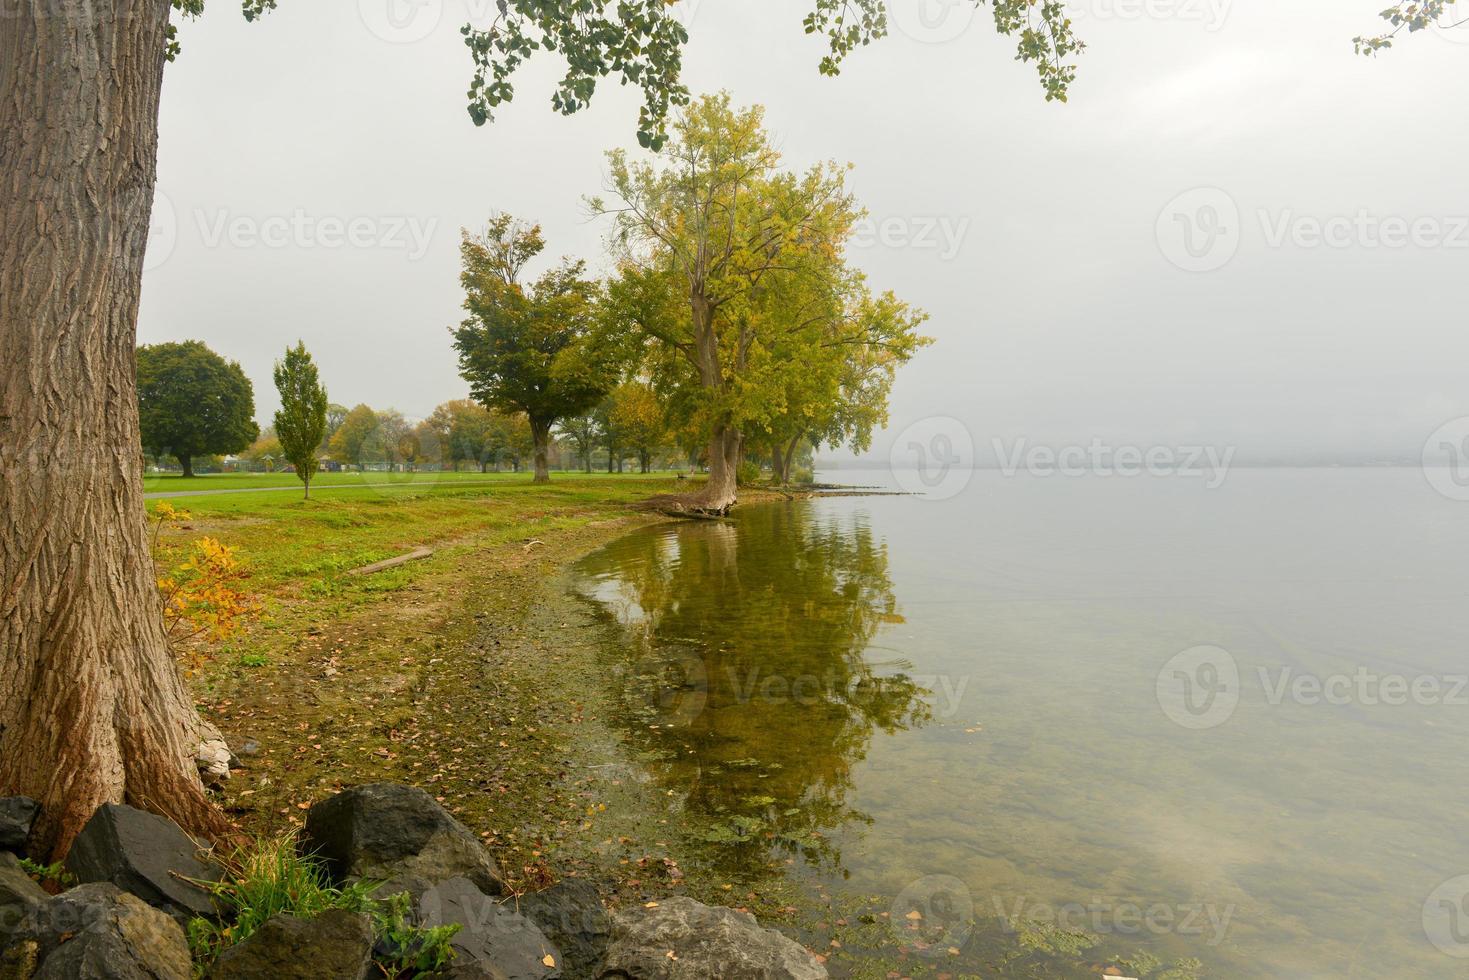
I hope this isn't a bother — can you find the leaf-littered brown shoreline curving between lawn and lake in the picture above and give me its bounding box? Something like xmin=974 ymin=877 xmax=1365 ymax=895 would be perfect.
xmin=180 ymin=486 xmax=1204 ymax=977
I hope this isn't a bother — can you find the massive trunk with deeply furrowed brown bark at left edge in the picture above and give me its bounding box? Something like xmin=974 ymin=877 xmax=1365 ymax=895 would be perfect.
xmin=0 ymin=0 xmax=228 ymax=858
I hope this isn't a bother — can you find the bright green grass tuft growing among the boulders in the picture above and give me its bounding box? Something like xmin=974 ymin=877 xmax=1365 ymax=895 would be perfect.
xmin=188 ymin=833 xmax=460 ymax=980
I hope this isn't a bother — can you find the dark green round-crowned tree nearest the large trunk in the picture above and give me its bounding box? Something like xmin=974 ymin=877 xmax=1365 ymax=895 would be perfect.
xmin=138 ymin=341 xmax=260 ymax=476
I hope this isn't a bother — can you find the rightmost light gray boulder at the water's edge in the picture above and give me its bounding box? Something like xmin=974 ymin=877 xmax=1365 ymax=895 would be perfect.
xmin=601 ymin=896 xmax=827 ymax=980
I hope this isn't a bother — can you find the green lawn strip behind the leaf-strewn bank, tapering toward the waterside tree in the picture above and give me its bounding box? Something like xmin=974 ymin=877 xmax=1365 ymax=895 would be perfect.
xmin=148 ymin=475 xmax=690 ymax=687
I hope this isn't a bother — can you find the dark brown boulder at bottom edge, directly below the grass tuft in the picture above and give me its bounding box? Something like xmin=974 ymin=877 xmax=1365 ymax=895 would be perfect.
xmin=209 ymin=908 xmax=373 ymax=980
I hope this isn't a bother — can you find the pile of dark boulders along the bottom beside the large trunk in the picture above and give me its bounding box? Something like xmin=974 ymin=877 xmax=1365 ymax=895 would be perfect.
xmin=0 ymin=783 xmax=827 ymax=980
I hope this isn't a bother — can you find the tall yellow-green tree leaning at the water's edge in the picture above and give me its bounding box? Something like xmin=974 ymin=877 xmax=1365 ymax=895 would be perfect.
xmin=592 ymin=94 xmax=923 ymax=514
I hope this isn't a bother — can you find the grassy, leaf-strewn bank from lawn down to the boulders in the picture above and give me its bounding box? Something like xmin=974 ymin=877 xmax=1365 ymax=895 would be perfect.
xmin=148 ymin=475 xmax=722 ymax=883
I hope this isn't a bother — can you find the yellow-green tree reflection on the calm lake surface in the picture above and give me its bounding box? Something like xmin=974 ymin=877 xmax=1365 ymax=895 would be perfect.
xmin=579 ymin=504 xmax=928 ymax=876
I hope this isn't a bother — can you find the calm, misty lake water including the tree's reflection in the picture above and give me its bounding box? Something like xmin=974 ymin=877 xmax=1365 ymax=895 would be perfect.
xmin=579 ymin=469 xmax=1469 ymax=977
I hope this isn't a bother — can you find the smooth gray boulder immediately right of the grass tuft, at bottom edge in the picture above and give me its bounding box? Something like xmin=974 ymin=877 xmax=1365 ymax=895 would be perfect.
xmin=419 ymin=879 xmax=566 ymax=980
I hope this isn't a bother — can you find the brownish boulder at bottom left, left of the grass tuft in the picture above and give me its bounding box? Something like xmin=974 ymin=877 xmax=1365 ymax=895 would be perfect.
xmin=6 ymin=883 xmax=192 ymax=980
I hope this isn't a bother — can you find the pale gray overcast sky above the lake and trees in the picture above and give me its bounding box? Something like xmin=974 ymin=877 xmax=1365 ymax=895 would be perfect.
xmin=138 ymin=0 xmax=1469 ymax=457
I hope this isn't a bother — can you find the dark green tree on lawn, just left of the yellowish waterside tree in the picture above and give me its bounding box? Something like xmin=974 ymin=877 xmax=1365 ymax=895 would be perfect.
xmin=451 ymin=215 xmax=617 ymax=483
